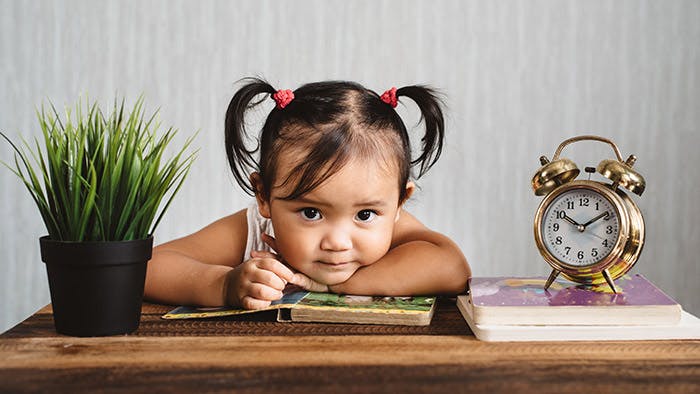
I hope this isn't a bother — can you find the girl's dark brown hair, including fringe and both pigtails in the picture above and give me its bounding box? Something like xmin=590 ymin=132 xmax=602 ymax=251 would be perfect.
xmin=225 ymin=78 xmax=445 ymax=205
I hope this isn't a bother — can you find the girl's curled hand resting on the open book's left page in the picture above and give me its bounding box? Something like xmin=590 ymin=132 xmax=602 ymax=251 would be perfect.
xmin=226 ymin=252 xmax=294 ymax=309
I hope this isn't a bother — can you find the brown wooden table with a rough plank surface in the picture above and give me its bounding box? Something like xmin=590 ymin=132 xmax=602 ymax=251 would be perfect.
xmin=0 ymin=299 xmax=700 ymax=393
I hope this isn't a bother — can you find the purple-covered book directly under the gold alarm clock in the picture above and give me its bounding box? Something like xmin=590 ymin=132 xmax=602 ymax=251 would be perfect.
xmin=469 ymin=274 xmax=681 ymax=325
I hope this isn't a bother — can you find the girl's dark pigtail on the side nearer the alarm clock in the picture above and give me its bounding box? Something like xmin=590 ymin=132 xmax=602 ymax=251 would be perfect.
xmin=396 ymin=86 xmax=445 ymax=178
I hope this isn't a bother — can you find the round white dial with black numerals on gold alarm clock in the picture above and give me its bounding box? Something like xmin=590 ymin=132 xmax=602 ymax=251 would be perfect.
xmin=540 ymin=189 xmax=620 ymax=266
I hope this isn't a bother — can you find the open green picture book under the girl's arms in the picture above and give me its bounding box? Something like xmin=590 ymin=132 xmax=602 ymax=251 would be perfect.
xmin=162 ymin=290 xmax=436 ymax=326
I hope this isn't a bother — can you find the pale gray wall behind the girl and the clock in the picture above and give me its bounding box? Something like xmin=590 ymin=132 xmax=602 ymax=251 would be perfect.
xmin=0 ymin=0 xmax=700 ymax=332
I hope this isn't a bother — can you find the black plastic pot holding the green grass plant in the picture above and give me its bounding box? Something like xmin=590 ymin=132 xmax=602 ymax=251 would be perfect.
xmin=39 ymin=237 xmax=153 ymax=337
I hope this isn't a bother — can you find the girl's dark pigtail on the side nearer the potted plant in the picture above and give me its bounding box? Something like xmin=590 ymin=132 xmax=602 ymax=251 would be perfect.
xmin=224 ymin=78 xmax=275 ymax=195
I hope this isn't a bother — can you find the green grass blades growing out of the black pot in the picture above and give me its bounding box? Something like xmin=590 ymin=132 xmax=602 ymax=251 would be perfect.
xmin=0 ymin=97 xmax=196 ymax=242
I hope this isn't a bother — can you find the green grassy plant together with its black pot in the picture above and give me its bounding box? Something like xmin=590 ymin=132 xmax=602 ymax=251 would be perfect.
xmin=0 ymin=97 xmax=195 ymax=336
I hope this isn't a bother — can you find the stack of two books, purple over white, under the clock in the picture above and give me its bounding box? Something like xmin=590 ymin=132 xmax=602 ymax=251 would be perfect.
xmin=457 ymin=274 xmax=700 ymax=341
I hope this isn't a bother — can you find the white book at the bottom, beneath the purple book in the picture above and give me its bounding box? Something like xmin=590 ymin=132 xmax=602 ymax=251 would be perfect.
xmin=457 ymin=296 xmax=700 ymax=342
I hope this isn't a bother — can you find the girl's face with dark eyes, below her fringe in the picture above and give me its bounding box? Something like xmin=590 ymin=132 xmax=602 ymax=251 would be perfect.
xmin=259 ymin=160 xmax=412 ymax=285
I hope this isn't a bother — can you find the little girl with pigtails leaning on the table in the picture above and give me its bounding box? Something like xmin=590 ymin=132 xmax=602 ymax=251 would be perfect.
xmin=145 ymin=79 xmax=470 ymax=309
